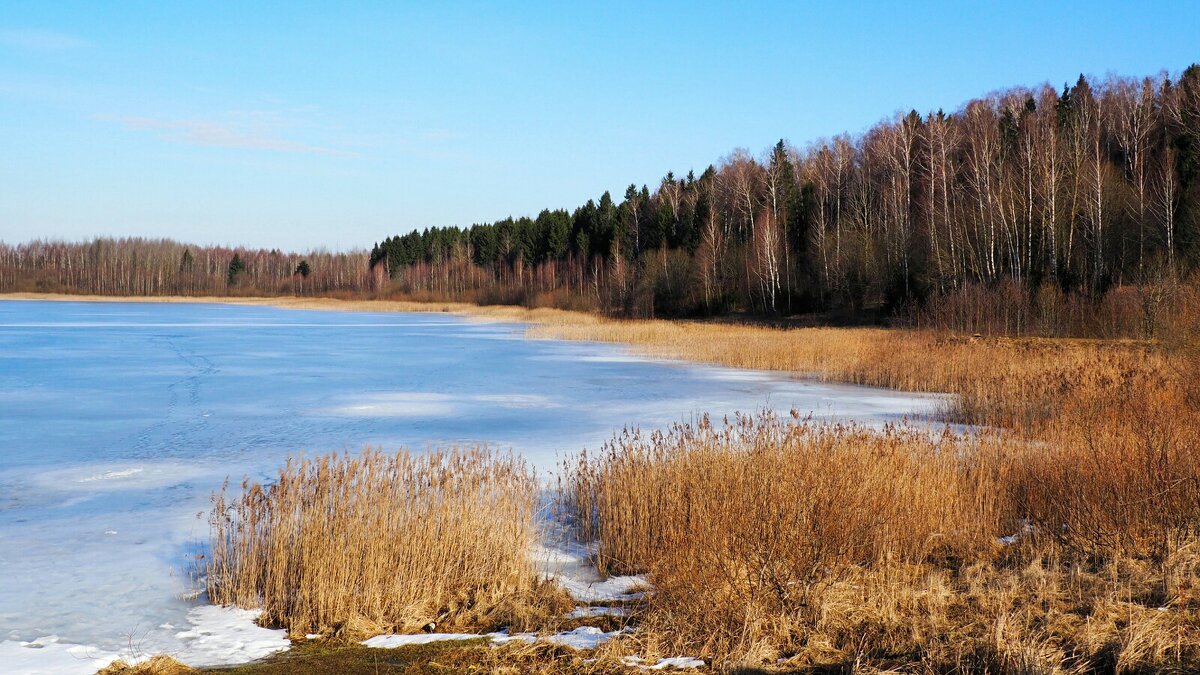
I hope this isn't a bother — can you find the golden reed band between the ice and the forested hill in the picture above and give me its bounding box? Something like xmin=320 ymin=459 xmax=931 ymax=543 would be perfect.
xmin=532 ymin=321 xmax=1168 ymax=426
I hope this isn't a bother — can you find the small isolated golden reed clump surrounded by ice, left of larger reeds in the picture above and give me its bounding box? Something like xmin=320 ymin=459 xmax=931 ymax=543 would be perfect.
xmin=208 ymin=448 xmax=554 ymax=637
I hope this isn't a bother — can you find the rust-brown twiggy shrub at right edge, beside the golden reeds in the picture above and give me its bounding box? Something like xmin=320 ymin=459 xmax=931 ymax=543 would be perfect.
xmin=1009 ymin=371 xmax=1200 ymax=561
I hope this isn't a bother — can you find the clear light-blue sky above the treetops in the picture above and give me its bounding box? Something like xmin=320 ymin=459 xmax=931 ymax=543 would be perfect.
xmin=0 ymin=0 xmax=1200 ymax=249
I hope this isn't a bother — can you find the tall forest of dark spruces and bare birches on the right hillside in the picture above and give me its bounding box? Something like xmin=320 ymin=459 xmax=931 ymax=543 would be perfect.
xmin=371 ymin=65 xmax=1200 ymax=324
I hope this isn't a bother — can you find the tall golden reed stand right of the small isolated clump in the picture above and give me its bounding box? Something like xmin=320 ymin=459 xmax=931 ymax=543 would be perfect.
xmin=560 ymin=413 xmax=1013 ymax=576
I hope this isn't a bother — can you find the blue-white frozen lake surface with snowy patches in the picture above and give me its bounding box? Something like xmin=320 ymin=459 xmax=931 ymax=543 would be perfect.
xmin=0 ymin=301 xmax=937 ymax=671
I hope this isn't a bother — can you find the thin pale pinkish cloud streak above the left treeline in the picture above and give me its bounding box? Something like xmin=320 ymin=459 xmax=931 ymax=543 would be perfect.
xmin=100 ymin=117 xmax=354 ymax=157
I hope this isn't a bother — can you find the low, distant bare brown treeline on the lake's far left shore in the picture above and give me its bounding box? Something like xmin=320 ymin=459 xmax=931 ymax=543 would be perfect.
xmin=0 ymin=238 xmax=377 ymax=295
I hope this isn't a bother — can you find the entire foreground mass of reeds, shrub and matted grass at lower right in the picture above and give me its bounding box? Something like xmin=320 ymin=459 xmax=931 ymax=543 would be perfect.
xmin=559 ymin=404 xmax=1200 ymax=673
